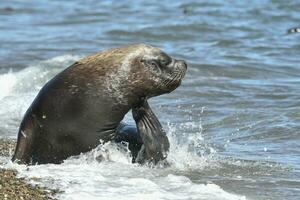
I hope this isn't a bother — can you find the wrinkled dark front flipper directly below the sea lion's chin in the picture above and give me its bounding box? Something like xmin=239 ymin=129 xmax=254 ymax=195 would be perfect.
xmin=132 ymin=99 xmax=170 ymax=164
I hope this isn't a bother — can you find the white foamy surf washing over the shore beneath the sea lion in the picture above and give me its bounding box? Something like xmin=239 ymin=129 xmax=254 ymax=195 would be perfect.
xmin=6 ymin=143 xmax=246 ymax=200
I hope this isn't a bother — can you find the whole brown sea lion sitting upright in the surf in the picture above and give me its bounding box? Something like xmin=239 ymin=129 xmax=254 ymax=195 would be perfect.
xmin=12 ymin=44 xmax=187 ymax=164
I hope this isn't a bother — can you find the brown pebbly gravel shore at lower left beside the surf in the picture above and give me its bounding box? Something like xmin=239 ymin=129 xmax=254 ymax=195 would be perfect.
xmin=0 ymin=138 xmax=58 ymax=200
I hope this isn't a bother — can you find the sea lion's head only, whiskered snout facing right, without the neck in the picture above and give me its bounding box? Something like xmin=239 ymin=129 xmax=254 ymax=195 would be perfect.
xmin=124 ymin=44 xmax=187 ymax=97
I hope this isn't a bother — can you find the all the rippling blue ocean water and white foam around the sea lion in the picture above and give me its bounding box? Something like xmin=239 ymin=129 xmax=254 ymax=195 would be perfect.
xmin=0 ymin=0 xmax=300 ymax=200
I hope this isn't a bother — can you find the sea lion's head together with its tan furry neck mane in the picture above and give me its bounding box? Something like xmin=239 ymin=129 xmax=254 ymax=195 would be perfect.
xmin=79 ymin=44 xmax=187 ymax=105
